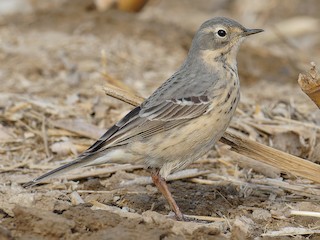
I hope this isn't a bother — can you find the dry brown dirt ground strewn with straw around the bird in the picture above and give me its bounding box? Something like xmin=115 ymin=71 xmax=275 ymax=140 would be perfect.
xmin=0 ymin=0 xmax=320 ymax=239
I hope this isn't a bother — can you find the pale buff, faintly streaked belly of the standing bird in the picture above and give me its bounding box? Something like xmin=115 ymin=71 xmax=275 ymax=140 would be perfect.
xmin=129 ymin=101 xmax=233 ymax=177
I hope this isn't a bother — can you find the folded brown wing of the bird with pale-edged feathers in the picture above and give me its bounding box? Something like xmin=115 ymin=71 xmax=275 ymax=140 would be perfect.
xmin=82 ymin=95 xmax=211 ymax=152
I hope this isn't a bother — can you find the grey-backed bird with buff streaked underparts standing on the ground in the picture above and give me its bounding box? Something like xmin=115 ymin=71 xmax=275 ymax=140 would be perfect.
xmin=24 ymin=17 xmax=263 ymax=221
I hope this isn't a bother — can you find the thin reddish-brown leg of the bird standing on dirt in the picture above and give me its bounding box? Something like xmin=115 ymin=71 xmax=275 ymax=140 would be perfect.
xmin=151 ymin=171 xmax=184 ymax=221
